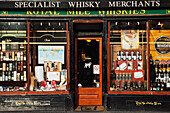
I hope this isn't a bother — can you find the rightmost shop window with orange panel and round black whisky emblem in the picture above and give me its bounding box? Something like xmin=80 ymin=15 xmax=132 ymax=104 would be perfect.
xmin=149 ymin=20 xmax=170 ymax=91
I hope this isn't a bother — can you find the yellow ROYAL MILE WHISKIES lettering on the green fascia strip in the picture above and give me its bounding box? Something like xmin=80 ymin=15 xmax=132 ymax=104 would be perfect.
xmin=25 ymin=10 xmax=145 ymax=15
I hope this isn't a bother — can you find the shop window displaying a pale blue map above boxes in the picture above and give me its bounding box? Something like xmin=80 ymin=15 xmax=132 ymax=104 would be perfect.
xmin=30 ymin=21 xmax=69 ymax=91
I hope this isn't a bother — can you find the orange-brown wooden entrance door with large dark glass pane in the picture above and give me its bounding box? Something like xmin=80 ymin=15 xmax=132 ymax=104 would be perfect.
xmin=75 ymin=38 xmax=102 ymax=106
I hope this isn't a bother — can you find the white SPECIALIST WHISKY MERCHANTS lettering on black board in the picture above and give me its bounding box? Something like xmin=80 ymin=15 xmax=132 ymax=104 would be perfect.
xmin=14 ymin=0 xmax=161 ymax=8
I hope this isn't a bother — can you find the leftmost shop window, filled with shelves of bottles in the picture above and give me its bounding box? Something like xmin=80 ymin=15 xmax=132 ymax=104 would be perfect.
xmin=0 ymin=21 xmax=28 ymax=92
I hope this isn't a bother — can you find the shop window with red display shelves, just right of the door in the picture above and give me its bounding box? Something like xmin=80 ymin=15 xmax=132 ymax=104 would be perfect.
xmin=108 ymin=21 xmax=148 ymax=91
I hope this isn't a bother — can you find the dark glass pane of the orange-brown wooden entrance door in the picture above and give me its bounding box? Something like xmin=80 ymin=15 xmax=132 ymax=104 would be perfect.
xmin=77 ymin=40 xmax=100 ymax=87
